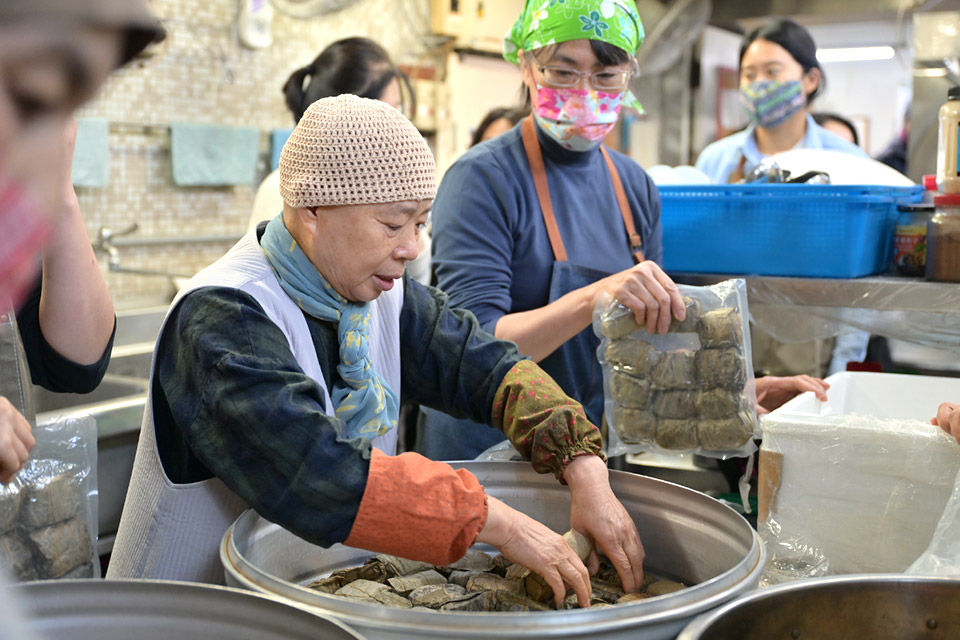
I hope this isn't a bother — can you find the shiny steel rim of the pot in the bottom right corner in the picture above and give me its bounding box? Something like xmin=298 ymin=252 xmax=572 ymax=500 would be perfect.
xmin=677 ymin=573 xmax=960 ymax=640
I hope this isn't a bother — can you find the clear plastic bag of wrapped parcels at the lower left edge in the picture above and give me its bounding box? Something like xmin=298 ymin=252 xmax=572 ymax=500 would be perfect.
xmin=0 ymin=416 xmax=100 ymax=582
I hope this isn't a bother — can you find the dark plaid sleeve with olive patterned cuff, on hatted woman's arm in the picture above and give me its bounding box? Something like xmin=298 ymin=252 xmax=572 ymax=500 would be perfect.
xmin=400 ymin=279 xmax=602 ymax=481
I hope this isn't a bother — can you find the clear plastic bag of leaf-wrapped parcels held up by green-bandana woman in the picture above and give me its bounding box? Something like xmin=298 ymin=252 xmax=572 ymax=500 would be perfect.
xmin=593 ymin=279 xmax=760 ymax=458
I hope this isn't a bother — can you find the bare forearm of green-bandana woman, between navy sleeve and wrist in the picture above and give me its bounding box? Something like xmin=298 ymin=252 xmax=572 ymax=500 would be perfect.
xmin=494 ymin=287 xmax=596 ymax=362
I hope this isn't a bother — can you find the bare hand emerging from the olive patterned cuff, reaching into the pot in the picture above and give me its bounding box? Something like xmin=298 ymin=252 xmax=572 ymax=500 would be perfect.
xmin=563 ymin=456 xmax=646 ymax=593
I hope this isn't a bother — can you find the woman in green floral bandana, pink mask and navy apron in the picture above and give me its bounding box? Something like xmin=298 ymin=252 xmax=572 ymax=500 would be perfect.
xmin=417 ymin=0 xmax=684 ymax=460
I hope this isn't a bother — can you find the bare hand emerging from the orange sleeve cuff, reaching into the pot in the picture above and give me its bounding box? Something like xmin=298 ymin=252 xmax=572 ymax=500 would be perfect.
xmin=477 ymin=496 xmax=591 ymax=607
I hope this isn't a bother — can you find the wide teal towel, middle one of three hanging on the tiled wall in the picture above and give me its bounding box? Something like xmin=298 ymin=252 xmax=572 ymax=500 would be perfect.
xmin=170 ymin=122 xmax=260 ymax=187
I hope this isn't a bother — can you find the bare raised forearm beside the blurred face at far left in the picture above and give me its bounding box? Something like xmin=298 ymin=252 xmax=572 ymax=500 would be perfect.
xmin=40 ymin=189 xmax=114 ymax=364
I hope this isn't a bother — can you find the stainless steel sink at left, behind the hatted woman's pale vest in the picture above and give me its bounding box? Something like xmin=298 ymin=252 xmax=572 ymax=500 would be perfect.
xmin=34 ymin=307 xmax=167 ymax=555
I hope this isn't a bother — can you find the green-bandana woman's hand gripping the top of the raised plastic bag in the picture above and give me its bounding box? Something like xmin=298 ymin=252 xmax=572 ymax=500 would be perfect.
xmin=594 ymin=260 xmax=686 ymax=334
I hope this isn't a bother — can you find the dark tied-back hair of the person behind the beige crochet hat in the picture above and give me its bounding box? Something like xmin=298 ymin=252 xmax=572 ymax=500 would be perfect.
xmin=283 ymin=38 xmax=416 ymax=122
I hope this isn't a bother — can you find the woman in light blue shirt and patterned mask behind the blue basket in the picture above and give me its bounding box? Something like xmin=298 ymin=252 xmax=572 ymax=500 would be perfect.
xmin=697 ymin=20 xmax=866 ymax=183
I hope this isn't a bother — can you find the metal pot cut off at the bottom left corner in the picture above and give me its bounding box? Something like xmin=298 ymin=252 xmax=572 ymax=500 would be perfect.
xmin=8 ymin=579 xmax=363 ymax=640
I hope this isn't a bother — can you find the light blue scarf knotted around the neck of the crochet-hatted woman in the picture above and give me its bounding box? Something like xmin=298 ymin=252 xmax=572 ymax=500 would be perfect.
xmin=260 ymin=215 xmax=399 ymax=439
